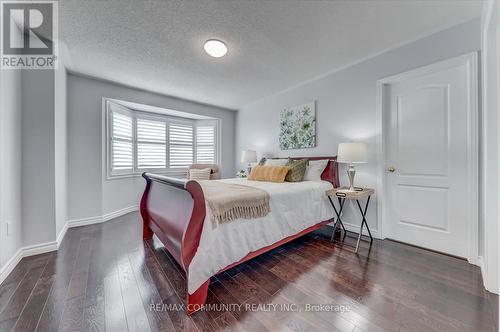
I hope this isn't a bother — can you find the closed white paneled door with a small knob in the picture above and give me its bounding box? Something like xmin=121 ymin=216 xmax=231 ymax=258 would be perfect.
xmin=384 ymin=56 xmax=475 ymax=257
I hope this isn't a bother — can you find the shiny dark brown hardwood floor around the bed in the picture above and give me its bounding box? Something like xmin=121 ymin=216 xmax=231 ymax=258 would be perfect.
xmin=0 ymin=213 xmax=498 ymax=332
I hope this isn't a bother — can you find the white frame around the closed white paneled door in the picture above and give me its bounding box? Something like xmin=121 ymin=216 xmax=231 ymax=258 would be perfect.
xmin=376 ymin=52 xmax=479 ymax=265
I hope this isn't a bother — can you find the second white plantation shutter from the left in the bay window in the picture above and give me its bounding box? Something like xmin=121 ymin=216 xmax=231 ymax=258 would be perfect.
xmin=137 ymin=118 xmax=167 ymax=169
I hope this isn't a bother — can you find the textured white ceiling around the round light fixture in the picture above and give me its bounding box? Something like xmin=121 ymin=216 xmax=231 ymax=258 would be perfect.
xmin=59 ymin=0 xmax=482 ymax=109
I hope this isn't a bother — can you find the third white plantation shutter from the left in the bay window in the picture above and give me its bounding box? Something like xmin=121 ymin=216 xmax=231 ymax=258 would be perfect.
xmin=168 ymin=123 xmax=193 ymax=168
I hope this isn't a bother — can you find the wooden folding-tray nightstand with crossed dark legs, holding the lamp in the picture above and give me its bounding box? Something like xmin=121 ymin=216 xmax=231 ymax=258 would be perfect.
xmin=326 ymin=188 xmax=375 ymax=253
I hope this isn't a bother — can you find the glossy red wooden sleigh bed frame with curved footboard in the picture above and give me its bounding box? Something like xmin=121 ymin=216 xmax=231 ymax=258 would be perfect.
xmin=141 ymin=157 xmax=339 ymax=315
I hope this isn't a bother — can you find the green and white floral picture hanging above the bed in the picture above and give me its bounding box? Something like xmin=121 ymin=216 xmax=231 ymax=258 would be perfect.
xmin=279 ymin=101 xmax=316 ymax=150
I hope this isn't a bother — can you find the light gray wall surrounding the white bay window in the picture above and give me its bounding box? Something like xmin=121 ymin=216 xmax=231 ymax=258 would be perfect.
xmin=67 ymin=74 xmax=235 ymax=220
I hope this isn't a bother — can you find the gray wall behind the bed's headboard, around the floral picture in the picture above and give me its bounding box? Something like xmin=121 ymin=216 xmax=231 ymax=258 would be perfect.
xmin=235 ymin=19 xmax=481 ymax=235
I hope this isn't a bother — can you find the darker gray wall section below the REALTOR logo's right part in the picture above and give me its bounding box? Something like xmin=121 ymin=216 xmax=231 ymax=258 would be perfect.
xmin=22 ymin=70 xmax=56 ymax=246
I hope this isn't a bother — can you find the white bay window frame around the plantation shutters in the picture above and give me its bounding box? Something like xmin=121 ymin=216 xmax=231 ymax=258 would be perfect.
xmin=103 ymin=98 xmax=221 ymax=180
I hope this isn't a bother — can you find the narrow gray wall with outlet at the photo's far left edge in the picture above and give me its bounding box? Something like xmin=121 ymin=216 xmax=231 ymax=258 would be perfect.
xmin=0 ymin=63 xmax=22 ymax=272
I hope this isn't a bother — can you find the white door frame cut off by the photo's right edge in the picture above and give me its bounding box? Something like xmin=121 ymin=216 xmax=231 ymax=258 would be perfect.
xmin=479 ymin=0 xmax=500 ymax=294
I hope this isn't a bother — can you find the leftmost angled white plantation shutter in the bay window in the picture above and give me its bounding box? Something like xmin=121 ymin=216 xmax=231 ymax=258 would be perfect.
xmin=111 ymin=111 xmax=134 ymax=171
